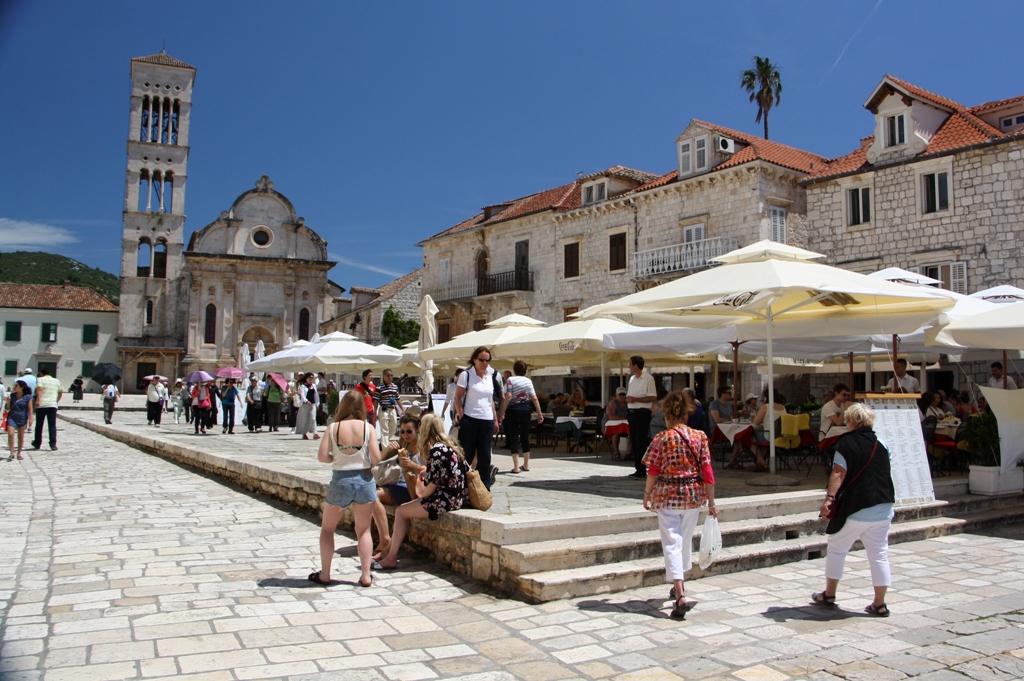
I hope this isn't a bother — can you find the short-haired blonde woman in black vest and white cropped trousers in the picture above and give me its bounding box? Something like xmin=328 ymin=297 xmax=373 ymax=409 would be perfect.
xmin=811 ymin=403 xmax=896 ymax=618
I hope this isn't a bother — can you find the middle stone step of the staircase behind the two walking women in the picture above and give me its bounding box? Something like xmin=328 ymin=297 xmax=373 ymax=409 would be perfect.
xmin=499 ymin=494 xmax=1024 ymax=574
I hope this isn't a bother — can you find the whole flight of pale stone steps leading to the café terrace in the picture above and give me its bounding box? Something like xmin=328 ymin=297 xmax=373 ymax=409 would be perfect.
xmin=497 ymin=479 xmax=1024 ymax=601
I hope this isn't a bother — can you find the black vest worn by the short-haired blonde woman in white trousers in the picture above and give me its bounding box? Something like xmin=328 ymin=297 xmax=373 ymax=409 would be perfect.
xmin=825 ymin=428 xmax=896 ymax=535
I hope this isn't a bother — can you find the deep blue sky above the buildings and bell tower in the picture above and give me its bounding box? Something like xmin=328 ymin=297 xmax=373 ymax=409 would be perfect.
xmin=0 ymin=0 xmax=1024 ymax=288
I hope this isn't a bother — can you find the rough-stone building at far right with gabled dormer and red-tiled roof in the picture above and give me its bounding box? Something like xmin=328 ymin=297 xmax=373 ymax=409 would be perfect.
xmin=801 ymin=75 xmax=1024 ymax=392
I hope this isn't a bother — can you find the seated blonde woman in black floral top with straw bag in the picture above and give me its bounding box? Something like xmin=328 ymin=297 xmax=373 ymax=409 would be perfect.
xmin=380 ymin=414 xmax=469 ymax=569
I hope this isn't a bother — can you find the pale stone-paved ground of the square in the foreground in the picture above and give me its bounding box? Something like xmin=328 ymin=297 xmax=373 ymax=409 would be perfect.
xmin=0 ymin=424 xmax=1024 ymax=681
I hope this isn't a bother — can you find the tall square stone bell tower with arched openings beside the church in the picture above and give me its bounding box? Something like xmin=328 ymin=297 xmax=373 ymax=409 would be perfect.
xmin=118 ymin=52 xmax=196 ymax=391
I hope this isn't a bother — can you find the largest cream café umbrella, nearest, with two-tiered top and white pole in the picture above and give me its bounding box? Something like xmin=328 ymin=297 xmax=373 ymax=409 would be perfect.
xmin=579 ymin=241 xmax=953 ymax=473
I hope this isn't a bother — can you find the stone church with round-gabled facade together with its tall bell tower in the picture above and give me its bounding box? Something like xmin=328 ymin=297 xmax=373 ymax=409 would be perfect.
xmin=118 ymin=53 xmax=341 ymax=391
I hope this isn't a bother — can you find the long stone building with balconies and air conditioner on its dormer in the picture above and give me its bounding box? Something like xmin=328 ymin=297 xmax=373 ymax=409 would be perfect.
xmin=419 ymin=120 xmax=827 ymax=401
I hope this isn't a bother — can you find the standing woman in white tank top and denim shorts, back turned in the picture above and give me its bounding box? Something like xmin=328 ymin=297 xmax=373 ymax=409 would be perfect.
xmin=309 ymin=390 xmax=381 ymax=587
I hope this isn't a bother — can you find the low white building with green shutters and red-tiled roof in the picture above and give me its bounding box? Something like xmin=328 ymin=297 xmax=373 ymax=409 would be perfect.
xmin=0 ymin=283 xmax=118 ymax=392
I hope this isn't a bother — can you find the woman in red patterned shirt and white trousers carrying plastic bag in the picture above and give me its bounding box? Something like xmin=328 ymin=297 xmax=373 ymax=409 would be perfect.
xmin=643 ymin=392 xmax=718 ymax=619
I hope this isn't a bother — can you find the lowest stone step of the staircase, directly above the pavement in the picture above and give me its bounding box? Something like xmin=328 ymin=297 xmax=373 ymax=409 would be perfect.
xmin=519 ymin=495 xmax=1024 ymax=602
